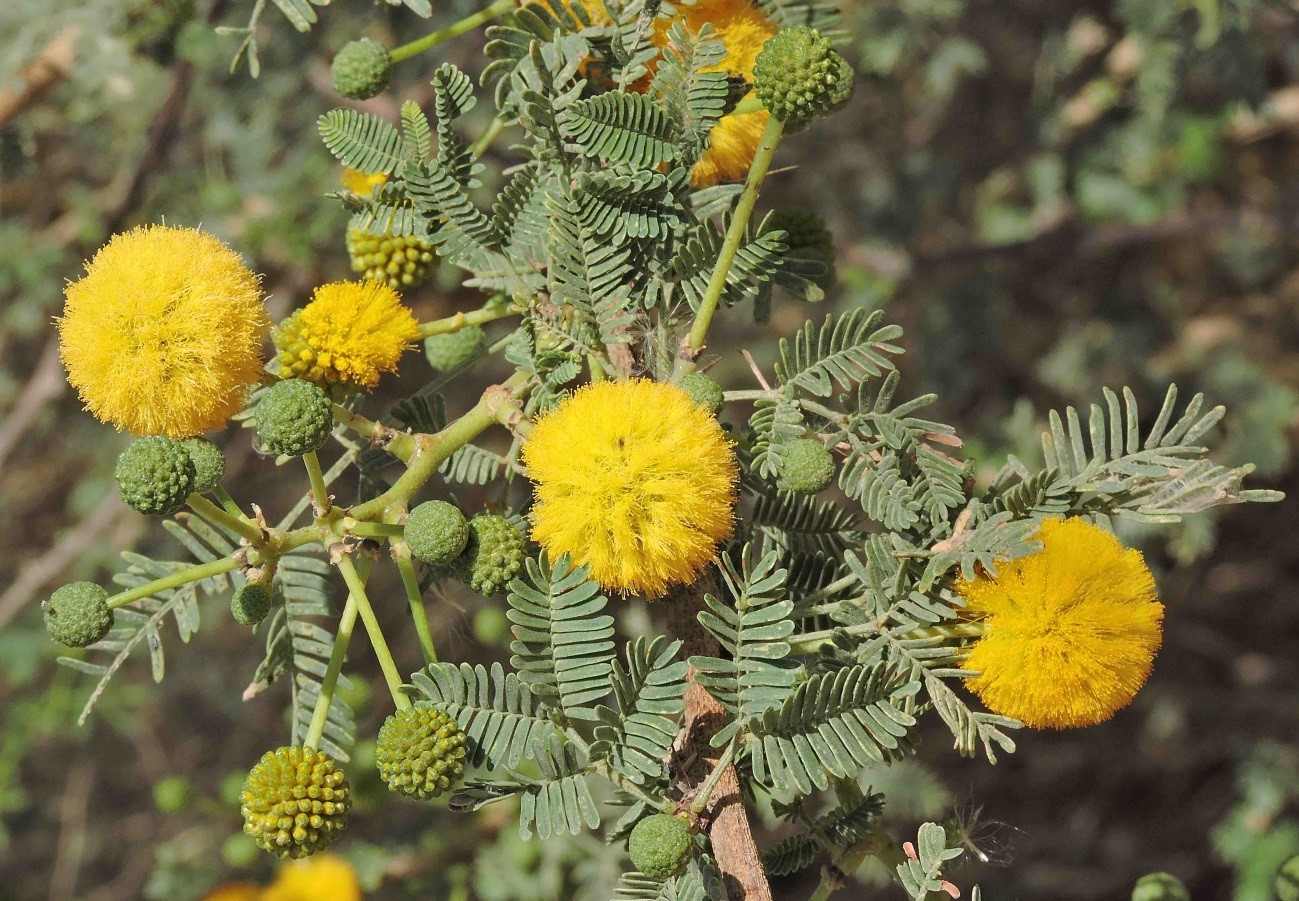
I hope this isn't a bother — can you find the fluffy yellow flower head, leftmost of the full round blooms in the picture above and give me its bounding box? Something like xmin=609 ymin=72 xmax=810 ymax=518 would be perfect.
xmin=57 ymin=226 xmax=270 ymax=438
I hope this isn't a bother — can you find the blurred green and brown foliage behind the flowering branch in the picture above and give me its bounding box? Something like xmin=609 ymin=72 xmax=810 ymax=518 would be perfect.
xmin=0 ymin=0 xmax=1299 ymax=901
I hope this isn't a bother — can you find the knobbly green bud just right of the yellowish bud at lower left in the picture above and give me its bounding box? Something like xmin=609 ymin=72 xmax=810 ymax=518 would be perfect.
xmin=374 ymin=706 xmax=468 ymax=798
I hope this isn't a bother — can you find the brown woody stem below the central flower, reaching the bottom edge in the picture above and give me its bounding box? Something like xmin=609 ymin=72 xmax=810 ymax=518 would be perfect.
xmin=665 ymin=576 xmax=772 ymax=901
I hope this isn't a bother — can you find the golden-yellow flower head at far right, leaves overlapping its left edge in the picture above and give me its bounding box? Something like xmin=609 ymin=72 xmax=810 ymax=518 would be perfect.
xmin=956 ymin=518 xmax=1164 ymax=728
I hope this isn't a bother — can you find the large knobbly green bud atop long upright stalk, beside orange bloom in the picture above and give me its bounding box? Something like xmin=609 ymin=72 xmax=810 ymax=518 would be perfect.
xmin=753 ymin=26 xmax=852 ymax=129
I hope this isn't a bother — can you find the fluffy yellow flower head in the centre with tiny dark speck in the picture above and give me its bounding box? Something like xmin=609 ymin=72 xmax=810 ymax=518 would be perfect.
xmin=523 ymin=379 xmax=737 ymax=597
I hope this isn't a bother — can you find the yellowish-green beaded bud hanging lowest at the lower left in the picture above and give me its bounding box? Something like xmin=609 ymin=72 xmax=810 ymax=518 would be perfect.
xmin=239 ymin=745 xmax=352 ymax=859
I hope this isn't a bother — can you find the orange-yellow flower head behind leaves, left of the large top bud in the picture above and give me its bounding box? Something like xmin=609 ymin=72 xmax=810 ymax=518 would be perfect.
xmin=655 ymin=0 xmax=778 ymax=188
